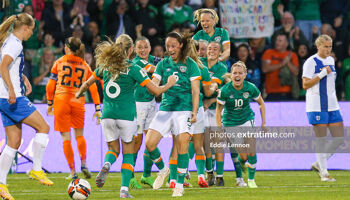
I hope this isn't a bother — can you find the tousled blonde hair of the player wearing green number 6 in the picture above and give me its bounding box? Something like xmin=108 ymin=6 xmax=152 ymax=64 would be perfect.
xmin=95 ymin=38 xmax=130 ymax=80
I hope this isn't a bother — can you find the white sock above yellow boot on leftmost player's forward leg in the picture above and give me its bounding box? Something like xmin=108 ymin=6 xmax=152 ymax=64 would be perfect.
xmin=33 ymin=133 xmax=49 ymax=171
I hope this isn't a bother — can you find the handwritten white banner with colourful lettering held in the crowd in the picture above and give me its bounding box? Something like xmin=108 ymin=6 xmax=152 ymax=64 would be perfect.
xmin=219 ymin=0 xmax=274 ymax=38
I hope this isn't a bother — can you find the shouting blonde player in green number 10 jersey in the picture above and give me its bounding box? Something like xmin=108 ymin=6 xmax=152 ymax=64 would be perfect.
xmin=216 ymin=61 xmax=266 ymax=188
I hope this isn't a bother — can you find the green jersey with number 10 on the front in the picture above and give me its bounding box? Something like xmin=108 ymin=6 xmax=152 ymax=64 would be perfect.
xmin=217 ymin=81 xmax=260 ymax=126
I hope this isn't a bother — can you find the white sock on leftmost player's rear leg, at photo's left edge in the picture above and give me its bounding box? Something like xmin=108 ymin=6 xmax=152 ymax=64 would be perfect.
xmin=0 ymin=145 xmax=17 ymax=185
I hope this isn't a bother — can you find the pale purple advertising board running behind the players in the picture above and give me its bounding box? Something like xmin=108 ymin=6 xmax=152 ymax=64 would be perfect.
xmin=0 ymin=102 xmax=350 ymax=172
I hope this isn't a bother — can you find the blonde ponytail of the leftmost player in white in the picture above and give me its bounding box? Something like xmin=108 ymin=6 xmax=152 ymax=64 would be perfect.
xmin=0 ymin=13 xmax=34 ymax=47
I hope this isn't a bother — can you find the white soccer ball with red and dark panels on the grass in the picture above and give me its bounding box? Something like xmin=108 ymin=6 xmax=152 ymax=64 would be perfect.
xmin=68 ymin=178 xmax=91 ymax=200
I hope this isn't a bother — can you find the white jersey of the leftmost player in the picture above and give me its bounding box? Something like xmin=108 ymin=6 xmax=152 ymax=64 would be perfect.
xmin=0 ymin=33 xmax=24 ymax=98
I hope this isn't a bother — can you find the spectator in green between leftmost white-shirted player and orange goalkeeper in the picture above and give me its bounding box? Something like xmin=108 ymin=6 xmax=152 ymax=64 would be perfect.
xmin=32 ymin=48 xmax=55 ymax=103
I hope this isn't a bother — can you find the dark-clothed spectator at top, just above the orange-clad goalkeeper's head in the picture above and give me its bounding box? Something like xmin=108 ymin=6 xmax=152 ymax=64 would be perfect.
xmin=42 ymin=0 xmax=78 ymax=46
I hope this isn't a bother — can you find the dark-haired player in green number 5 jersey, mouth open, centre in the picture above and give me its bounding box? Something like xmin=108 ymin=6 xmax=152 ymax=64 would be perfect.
xmin=146 ymin=32 xmax=201 ymax=197
